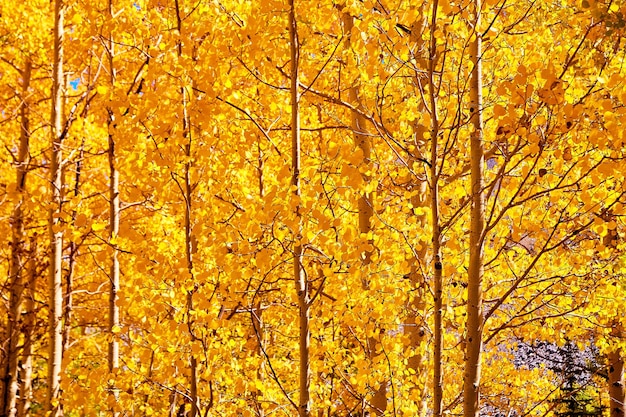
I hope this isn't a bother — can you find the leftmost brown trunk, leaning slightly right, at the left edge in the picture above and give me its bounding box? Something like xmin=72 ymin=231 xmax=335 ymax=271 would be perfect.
xmin=0 ymin=60 xmax=32 ymax=417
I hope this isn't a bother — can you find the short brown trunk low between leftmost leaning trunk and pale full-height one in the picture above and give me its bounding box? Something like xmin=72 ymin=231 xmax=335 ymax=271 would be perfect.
xmin=17 ymin=238 xmax=37 ymax=417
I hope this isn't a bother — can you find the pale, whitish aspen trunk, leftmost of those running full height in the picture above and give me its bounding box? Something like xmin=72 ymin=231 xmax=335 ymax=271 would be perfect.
xmin=46 ymin=0 xmax=64 ymax=417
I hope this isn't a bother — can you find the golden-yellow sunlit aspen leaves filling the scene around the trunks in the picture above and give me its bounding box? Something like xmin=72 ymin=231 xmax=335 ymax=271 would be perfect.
xmin=0 ymin=0 xmax=626 ymax=415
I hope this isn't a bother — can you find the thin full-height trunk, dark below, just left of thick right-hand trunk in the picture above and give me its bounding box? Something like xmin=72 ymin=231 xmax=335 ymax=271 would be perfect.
xmin=428 ymin=0 xmax=443 ymax=417
